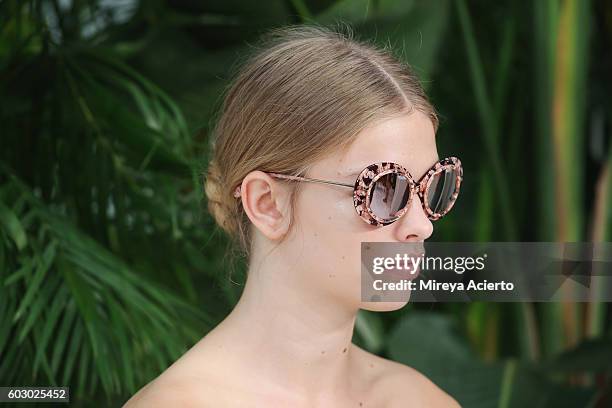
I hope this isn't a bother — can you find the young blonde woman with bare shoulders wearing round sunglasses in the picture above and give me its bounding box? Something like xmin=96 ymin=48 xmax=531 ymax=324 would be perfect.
xmin=125 ymin=26 xmax=460 ymax=407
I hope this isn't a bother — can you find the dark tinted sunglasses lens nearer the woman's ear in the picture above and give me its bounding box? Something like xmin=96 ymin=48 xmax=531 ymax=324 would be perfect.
xmin=370 ymin=173 xmax=410 ymax=219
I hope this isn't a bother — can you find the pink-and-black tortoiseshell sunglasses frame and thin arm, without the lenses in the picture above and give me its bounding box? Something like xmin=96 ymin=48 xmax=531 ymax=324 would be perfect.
xmin=234 ymin=157 xmax=463 ymax=226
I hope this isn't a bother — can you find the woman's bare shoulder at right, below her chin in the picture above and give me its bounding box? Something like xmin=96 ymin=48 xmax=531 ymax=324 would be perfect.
xmin=354 ymin=346 xmax=460 ymax=408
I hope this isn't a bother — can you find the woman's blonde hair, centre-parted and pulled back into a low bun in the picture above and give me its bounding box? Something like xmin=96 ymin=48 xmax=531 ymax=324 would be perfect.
xmin=205 ymin=25 xmax=438 ymax=257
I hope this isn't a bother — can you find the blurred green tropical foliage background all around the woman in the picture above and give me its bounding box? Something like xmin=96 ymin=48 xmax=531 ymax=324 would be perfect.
xmin=0 ymin=0 xmax=612 ymax=408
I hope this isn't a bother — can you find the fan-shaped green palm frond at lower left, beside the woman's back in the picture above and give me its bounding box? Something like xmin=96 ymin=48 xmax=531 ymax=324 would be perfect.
xmin=0 ymin=174 xmax=209 ymax=395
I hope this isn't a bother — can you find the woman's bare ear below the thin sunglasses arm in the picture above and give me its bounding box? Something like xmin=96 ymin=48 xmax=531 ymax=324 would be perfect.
xmin=241 ymin=170 xmax=291 ymax=240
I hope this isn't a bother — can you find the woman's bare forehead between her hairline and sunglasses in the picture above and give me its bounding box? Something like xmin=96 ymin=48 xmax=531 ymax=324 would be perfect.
xmin=329 ymin=111 xmax=439 ymax=179
